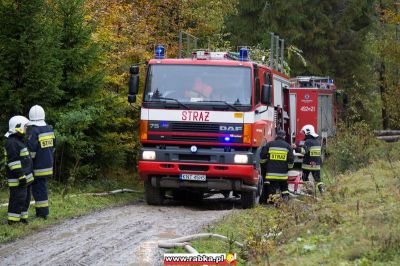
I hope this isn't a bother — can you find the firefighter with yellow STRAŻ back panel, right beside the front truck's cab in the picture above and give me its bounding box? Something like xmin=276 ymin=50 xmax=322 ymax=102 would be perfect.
xmin=260 ymin=130 xmax=294 ymax=202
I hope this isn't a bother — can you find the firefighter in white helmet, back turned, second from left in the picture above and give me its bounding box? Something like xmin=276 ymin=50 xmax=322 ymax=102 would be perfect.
xmin=27 ymin=105 xmax=55 ymax=219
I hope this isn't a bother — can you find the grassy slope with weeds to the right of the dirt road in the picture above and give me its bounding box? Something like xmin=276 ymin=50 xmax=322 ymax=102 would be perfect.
xmin=177 ymin=161 xmax=400 ymax=265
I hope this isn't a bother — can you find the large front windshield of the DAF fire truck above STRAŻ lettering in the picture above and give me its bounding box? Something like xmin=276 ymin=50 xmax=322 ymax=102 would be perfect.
xmin=144 ymin=65 xmax=251 ymax=110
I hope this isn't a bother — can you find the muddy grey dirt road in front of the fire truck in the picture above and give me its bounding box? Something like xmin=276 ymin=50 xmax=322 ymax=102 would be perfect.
xmin=0 ymin=199 xmax=239 ymax=265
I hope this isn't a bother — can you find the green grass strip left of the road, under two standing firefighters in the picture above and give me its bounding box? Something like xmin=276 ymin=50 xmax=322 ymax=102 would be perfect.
xmin=0 ymin=174 xmax=143 ymax=243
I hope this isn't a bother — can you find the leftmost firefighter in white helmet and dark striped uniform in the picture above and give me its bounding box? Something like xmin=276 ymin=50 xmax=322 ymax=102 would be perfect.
xmin=5 ymin=116 xmax=33 ymax=225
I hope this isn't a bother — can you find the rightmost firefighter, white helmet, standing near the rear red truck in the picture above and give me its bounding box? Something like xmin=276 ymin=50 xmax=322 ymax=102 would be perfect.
xmin=296 ymin=125 xmax=325 ymax=194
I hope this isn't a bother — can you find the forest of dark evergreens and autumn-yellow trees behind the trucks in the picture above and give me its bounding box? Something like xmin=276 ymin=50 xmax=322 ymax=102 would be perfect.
xmin=0 ymin=0 xmax=400 ymax=182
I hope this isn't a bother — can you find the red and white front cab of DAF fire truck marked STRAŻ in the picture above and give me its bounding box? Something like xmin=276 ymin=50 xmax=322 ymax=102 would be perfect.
xmin=128 ymin=46 xmax=290 ymax=208
